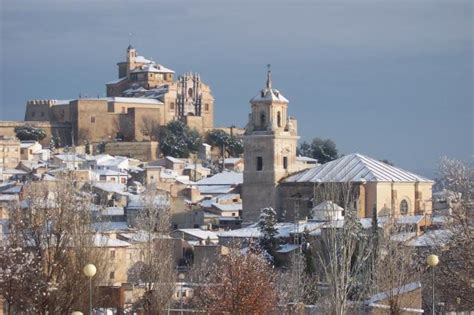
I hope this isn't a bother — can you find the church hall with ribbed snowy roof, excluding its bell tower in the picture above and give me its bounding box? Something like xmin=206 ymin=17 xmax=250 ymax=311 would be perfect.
xmin=276 ymin=153 xmax=433 ymax=220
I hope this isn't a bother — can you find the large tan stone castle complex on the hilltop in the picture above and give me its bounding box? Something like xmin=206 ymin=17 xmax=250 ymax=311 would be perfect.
xmin=25 ymin=46 xmax=214 ymax=143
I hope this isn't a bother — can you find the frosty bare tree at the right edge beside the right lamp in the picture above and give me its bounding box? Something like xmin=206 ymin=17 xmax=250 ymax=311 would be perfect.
xmin=435 ymin=158 xmax=474 ymax=311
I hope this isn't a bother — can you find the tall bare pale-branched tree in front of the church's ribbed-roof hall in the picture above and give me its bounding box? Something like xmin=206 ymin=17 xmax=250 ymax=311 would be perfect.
xmin=314 ymin=182 xmax=372 ymax=315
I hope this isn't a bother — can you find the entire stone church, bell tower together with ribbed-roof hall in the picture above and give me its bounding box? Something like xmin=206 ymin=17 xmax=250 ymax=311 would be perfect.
xmin=242 ymin=71 xmax=433 ymax=223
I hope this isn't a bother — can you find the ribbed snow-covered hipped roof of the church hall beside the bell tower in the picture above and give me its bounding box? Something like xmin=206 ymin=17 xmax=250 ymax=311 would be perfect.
xmin=284 ymin=153 xmax=432 ymax=183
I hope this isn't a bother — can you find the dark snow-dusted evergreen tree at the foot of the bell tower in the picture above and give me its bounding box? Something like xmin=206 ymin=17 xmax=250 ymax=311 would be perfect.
xmin=258 ymin=207 xmax=280 ymax=265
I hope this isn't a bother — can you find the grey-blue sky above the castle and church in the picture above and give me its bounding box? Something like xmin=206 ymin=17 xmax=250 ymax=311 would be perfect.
xmin=0 ymin=0 xmax=474 ymax=175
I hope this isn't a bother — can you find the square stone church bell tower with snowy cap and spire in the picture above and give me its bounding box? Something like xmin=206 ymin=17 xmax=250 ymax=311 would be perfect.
xmin=242 ymin=66 xmax=299 ymax=222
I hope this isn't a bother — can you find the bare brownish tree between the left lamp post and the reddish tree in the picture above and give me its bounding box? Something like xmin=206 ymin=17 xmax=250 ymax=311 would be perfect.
xmin=129 ymin=187 xmax=176 ymax=314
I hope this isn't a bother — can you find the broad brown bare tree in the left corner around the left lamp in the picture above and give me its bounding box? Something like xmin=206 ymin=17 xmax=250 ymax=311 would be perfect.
xmin=0 ymin=178 xmax=105 ymax=314
